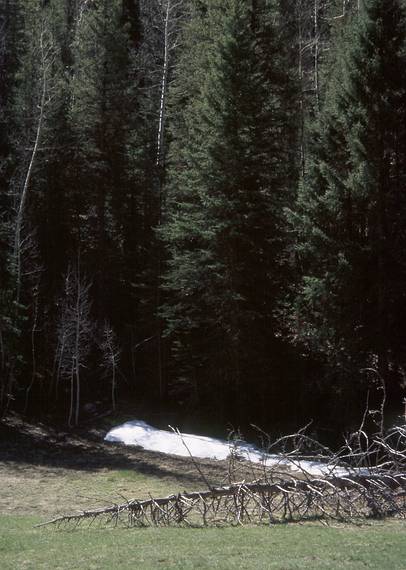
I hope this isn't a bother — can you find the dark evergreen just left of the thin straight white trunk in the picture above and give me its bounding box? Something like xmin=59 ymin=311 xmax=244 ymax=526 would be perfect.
xmin=68 ymin=0 xmax=160 ymax=404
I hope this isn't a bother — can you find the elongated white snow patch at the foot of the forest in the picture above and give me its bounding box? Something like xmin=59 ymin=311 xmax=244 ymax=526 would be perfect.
xmin=104 ymin=420 xmax=348 ymax=476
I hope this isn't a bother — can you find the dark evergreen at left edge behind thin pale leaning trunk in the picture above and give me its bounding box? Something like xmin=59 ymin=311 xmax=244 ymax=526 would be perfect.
xmin=2 ymin=0 xmax=67 ymax=408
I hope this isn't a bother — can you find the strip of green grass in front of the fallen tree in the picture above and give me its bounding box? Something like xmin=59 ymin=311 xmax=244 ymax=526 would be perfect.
xmin=0 ymin=516 xmax=406 ymax=570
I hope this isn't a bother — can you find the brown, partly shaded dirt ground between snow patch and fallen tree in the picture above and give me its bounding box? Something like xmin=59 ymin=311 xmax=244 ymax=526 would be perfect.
xmin=0 ymin=414 xmax=264 ymax=516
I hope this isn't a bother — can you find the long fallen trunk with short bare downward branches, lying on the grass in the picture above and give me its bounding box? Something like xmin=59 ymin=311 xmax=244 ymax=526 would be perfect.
xmin=36 ymin=473 xmax=406 ymax=527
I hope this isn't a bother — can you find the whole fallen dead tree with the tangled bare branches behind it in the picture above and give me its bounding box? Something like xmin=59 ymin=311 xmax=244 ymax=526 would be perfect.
xmin=37 ymin=418 xmax=406 ymax=527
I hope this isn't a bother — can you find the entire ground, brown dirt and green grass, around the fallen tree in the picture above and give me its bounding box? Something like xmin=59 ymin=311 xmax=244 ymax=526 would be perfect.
xmin=0 ymin=415 xmax=406 ymax=570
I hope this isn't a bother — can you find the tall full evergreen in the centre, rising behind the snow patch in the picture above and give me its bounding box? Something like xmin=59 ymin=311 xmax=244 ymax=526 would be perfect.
xmin=162 ymin=0 xmax=293 ymax=418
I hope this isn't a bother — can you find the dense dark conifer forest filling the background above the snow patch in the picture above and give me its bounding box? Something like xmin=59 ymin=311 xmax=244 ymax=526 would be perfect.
xmin=0 ymin=0 xmax=406 ymax=428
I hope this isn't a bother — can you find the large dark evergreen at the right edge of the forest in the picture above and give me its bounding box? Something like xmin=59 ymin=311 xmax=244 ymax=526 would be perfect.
xmin=290 ymin=0 xmax=406 ymax=400
